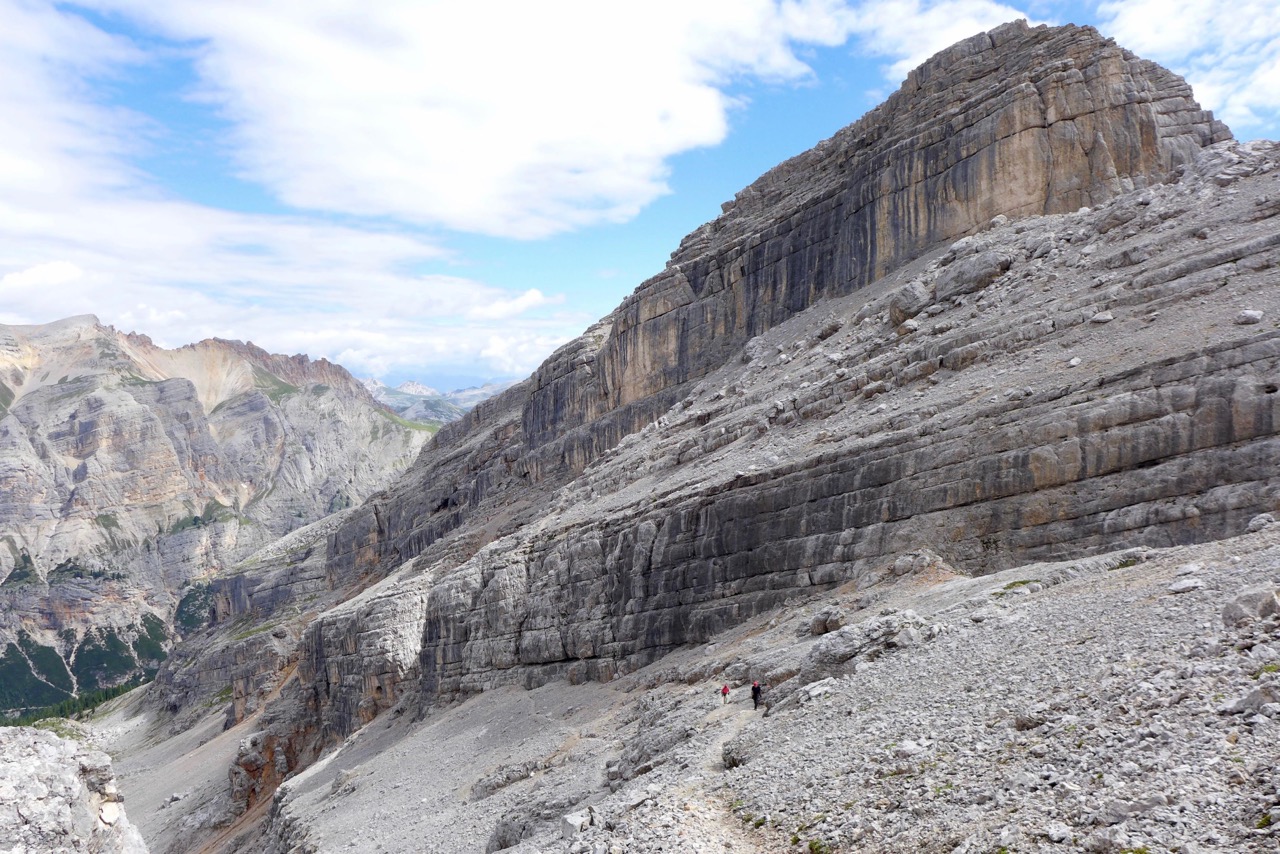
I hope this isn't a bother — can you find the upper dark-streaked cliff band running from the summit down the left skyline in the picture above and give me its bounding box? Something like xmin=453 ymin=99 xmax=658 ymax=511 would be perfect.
xmin=320 ymin=22 xmax=1230 ymax=601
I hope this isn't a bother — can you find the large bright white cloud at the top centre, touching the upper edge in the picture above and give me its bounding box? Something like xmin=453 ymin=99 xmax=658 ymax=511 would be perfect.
xmin=77 ymin=0 xmax=852 ymax=238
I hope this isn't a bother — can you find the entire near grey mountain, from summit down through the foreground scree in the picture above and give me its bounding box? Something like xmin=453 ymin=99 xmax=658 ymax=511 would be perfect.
xmin=77 ymin=22 xmax=1280 ymax=854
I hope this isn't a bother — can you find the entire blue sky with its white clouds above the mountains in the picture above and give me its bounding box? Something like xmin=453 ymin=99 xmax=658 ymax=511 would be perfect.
xmin=0 ymin=0 xmax=1280 ymax=388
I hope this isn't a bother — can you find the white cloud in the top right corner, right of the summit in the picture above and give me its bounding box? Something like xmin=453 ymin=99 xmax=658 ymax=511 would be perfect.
xmin=1098 ymin=0 xmax=1280 ymax=138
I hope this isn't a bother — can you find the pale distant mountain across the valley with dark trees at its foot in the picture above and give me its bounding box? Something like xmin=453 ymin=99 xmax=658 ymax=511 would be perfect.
xmin=0 ymin=318 xmax=428 ymax=708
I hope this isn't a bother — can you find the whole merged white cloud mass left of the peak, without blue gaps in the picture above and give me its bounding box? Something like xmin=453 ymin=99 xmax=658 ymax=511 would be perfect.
xmin=0 ymin=0 xmax=890 ymax=374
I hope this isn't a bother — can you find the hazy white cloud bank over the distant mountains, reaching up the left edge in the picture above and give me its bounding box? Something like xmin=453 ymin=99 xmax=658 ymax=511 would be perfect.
xmin=0 ymin=0 xmax=589 ymax=374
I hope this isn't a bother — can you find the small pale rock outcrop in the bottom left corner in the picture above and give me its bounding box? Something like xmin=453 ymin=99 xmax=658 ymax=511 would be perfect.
xmin=0 ymin=727 xmax=147 ymax=854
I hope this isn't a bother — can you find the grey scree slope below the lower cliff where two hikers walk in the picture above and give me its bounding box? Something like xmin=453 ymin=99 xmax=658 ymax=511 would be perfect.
xmin=145 ymin=516 xmax=1280 ymax=854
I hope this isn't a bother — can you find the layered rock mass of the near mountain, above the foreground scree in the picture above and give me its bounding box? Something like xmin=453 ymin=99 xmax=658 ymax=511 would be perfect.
xmin=152 ymin=24 xmax=1280 ymax=834
